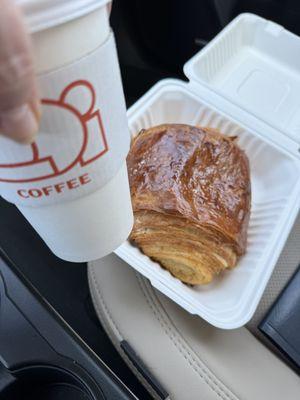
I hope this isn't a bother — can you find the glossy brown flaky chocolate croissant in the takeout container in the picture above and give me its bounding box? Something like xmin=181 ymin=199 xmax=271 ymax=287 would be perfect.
xmin=127 ymin=124 xmax=251 ymax=284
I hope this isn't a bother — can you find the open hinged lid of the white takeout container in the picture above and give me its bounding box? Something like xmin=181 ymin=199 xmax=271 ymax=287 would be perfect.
xmin=184 ymin=14 xmax=300 ymax=147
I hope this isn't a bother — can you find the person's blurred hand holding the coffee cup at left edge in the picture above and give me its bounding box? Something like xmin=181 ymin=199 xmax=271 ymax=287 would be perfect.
xmin=0 ymin=0 xmax=40 ymax=143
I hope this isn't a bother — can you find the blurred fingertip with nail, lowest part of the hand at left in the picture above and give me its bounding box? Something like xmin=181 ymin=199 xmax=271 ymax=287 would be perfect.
xmin=0 ymin=104 xmax=38 ymax=144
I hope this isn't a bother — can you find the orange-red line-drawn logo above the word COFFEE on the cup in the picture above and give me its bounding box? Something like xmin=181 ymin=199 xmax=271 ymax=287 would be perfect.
xmin=0 ymin=80 xmax=108 ymax=183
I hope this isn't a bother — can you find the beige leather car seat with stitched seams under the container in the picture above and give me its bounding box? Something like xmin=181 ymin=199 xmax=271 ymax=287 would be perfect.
xmin=89 ymin=218 xmax=300 ymax=400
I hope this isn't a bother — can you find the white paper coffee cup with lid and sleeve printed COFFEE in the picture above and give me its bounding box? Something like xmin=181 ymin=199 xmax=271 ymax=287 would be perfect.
xmin=0 ymin=0 xmax=133 ymax=262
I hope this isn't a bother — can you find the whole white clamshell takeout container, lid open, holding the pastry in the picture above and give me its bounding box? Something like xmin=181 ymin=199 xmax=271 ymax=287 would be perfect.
xmin=116 ymin=14 xmax=300 ymax=329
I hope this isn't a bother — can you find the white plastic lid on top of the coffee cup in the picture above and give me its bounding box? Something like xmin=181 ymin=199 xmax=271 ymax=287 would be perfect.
xmin=15 ymin=0 xmax=111 ymax=32
